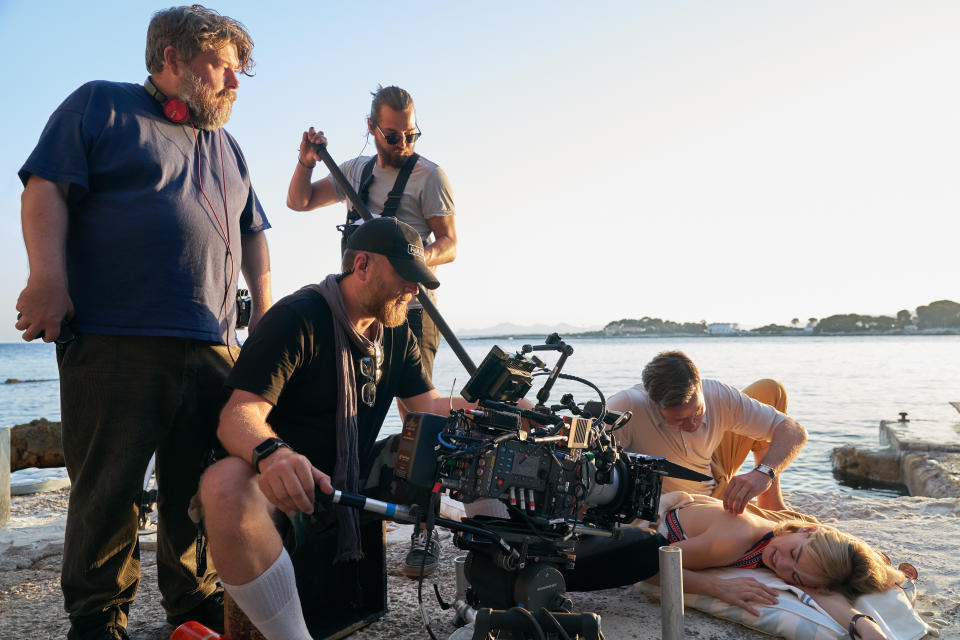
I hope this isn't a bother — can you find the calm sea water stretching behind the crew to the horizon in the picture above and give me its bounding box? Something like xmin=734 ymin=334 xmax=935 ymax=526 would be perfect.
xmin=0 ymin=336 xmax=960 ymax=492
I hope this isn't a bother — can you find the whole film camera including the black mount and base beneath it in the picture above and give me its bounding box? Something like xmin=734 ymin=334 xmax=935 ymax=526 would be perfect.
xmin=350 ymin=334 xmax=707 ymax=638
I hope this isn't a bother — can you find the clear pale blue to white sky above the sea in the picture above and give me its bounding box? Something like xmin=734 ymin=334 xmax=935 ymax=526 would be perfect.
xmin=0 ymin=0 xmax=960 ymax=342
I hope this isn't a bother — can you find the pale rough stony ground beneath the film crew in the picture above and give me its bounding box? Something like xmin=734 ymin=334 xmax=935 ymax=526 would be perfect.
xmin=0 ymin=490 xmax=960 ymax=640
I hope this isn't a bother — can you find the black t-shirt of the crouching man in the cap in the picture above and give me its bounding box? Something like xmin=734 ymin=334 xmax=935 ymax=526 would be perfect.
xmin=227 ymin=290 xmax=432 ymax=474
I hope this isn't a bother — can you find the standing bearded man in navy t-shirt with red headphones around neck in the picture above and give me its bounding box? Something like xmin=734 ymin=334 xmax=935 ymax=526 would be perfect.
xmin=16 ymin=5 xmax=271 ymax=640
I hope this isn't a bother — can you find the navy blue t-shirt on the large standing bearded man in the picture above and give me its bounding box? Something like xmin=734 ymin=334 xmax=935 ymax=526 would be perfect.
xmin=19 ymin=80 xmax=270 ymax=344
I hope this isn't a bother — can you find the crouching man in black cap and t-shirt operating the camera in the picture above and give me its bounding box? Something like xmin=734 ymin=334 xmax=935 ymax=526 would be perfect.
xmin=192 ymin=218 xmax=472 ymax=640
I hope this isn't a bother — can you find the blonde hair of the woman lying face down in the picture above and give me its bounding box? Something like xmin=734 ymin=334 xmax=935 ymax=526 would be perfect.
xmin=773 ymin=520 xmax=904 ymax=602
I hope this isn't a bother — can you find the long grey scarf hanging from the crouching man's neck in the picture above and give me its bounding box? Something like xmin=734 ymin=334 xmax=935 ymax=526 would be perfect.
xmin=304 ymin=274 xmax=383 ymax=562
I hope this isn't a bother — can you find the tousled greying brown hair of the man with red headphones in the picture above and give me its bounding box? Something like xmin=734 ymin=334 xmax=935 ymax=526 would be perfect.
xmin=146 ymin=4 xmax=253 ymax=76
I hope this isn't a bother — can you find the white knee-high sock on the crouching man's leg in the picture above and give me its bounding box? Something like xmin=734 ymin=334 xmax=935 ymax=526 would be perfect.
xmin=221 ymin=549 xmax=312 ymax=640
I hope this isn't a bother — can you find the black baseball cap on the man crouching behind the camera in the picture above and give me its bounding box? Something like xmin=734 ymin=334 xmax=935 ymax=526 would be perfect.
xmin=347 ymin=216 xmax=440 ymax=289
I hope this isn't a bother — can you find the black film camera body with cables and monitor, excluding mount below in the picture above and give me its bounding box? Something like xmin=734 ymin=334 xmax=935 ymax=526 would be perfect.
xmin=395 ymin=334 xmax=675 ymax=540
